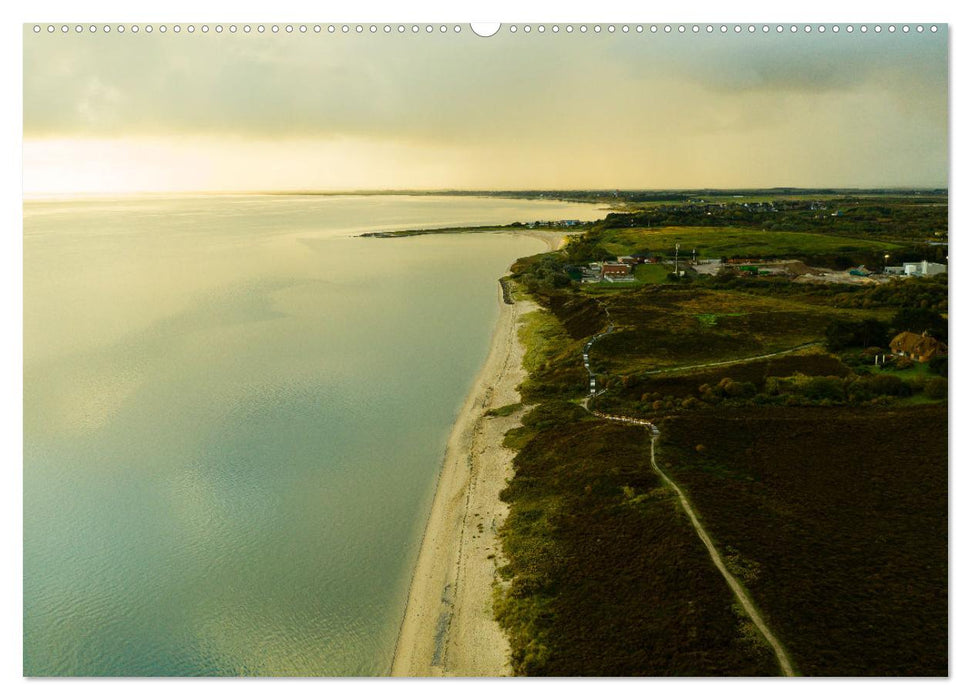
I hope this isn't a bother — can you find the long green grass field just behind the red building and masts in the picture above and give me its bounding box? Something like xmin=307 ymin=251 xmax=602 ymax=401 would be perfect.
xmin=603 ymin=226 xmax=900 ymax=258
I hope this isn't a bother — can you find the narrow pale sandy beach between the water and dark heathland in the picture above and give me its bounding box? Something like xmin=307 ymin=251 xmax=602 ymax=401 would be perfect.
xmin=391 ymin=247 xmax=561 ymax=677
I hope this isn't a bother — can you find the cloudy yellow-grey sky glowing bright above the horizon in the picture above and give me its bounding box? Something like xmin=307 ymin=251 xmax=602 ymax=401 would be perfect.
xmin=23 ymin=23 xmax=948 ymax=195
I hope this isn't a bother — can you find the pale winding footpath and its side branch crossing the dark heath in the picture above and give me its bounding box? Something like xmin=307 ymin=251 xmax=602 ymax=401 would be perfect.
xmin=582 ymin=309 xmax=796 ymax=676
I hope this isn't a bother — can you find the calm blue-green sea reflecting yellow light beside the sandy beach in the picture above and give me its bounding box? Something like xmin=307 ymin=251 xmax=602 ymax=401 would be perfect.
xmin=24 ymin=196 xmax=603 ymax=676
